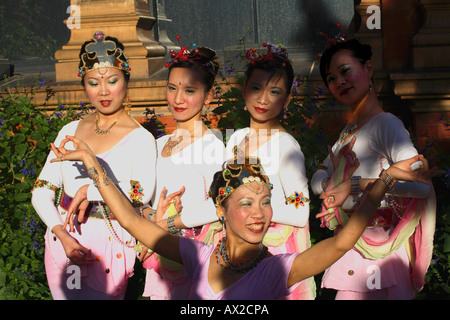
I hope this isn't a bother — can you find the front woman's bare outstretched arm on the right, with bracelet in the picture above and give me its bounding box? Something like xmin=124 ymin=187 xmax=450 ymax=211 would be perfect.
xmin=288 ymin=155 xmax=442 ymax=287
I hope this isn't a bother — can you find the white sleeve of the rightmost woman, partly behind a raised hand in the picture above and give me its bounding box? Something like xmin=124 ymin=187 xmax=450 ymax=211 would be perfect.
xmin=369 ymin=113 xmax=431 ymax=198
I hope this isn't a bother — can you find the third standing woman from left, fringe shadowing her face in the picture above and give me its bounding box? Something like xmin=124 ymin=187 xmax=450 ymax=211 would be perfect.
xmin=222 ymin=44 xmax=316 ymax=300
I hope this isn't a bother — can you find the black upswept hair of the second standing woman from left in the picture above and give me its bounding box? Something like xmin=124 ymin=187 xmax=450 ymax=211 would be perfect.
xmin=169 ymin=47 xmax=220 ymax=92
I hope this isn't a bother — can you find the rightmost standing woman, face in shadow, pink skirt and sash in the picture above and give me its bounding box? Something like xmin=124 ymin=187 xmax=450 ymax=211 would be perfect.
xmin=312 ymin=33 xmax=435 ymax=299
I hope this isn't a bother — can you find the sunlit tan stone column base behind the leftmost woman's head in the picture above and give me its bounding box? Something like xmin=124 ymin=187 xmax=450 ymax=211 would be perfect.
xmin=55 ymin=0 xmax=165 ymax=82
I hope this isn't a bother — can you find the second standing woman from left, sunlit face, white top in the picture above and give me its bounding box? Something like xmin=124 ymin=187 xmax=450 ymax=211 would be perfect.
xmin=139 ymin=36 xmax=225 ymax=300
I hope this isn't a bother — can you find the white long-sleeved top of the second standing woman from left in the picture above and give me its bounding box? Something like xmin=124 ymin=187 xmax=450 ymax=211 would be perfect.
xmin=152 ymin=132 xmax=225 ymax=228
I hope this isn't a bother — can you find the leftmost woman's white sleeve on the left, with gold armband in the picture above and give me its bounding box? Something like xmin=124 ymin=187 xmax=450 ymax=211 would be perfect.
xmin=31 ymin=121 xmax=79 ymax=230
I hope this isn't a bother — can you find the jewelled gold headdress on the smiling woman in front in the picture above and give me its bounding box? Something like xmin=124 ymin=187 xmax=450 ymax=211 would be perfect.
xmin=209 ymin=146 xmax=273 ymax=206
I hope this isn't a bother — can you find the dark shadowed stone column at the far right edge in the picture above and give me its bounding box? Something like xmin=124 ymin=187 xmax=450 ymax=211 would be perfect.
xmin=391 ymin=0 xmax=450 ymax=148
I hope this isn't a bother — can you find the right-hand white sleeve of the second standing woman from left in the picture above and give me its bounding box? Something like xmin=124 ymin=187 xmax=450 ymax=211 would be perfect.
xmin=181 ymin=135 xmax=225 ymax=228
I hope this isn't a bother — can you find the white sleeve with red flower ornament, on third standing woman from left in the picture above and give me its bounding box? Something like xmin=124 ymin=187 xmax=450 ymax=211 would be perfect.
xmin=272 ymin=135 xmax=309 ymax=228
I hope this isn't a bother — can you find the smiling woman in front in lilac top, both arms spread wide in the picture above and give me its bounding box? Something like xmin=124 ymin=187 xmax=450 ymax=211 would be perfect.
xmin=48 ymin=131 xmax=436 ymax=300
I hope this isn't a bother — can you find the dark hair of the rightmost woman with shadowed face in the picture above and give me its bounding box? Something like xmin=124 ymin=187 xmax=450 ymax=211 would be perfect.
xmin=320 ymin=39 xmax=372 ymax=87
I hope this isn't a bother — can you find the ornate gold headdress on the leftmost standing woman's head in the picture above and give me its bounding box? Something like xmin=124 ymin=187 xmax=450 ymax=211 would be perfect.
xmin=78 ymin=31 xmax=131 ymax=77
